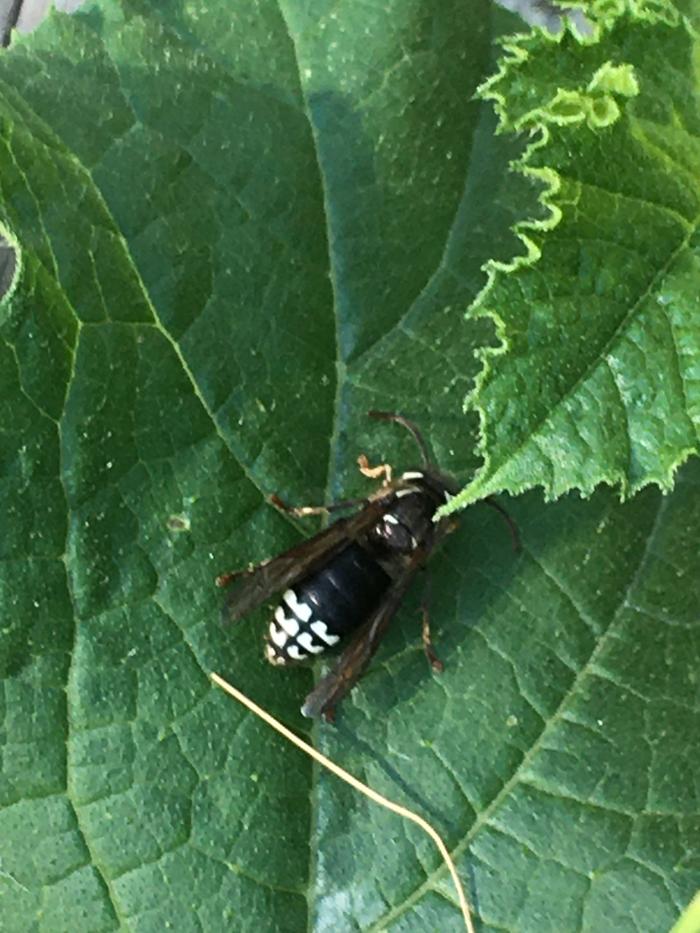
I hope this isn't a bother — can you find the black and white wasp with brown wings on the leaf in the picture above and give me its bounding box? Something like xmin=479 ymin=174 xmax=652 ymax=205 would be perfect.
xmin=217 ymin=411 xmax=512 ymax=719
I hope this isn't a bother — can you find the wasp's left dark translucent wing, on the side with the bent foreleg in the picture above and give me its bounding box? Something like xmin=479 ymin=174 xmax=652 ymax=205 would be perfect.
xmin=222 ymin=489 xmax=394 ymax=622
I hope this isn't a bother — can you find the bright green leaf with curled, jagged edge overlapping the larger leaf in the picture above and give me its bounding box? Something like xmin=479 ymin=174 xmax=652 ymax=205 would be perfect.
xmin=447 ymin=2 xmax=700 ymax=511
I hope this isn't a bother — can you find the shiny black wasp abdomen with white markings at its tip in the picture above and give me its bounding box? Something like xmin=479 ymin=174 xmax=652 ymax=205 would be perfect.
xmin=266 ymin=542 xmax=391 ymax=664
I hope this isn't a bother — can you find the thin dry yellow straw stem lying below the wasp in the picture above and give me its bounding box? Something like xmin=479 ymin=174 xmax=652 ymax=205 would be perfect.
xmin=209 ymin=673 xmax=474 ymax=933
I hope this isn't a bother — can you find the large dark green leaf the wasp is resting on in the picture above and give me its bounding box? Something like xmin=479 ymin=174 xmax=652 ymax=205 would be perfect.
xmin=0 ymin=0 xmax=700 ymax=933
